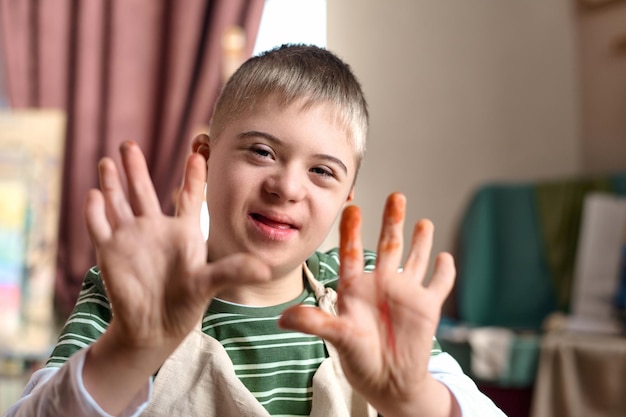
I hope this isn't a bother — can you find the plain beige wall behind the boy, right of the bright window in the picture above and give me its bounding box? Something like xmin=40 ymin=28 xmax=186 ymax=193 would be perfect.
xmin=325 ymin=0 xmax=581 ymax=260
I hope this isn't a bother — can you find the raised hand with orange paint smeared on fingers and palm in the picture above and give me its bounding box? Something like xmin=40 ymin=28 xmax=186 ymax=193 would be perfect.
xmin=281 ymin=193 xmax=458 ymax=417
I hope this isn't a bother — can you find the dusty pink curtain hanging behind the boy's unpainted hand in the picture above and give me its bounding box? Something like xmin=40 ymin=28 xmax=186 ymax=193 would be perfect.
xmin=0 ymin=0 xmax=264 ymax=319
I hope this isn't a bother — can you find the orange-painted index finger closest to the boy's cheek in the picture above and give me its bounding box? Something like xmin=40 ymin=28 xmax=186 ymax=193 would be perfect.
xmin=339 ymin=206 xmax=363 ymax=294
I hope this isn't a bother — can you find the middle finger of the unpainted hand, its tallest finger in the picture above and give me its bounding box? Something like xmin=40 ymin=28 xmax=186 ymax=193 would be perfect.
xmin=120 ymin=141 xmax=161 ymax=216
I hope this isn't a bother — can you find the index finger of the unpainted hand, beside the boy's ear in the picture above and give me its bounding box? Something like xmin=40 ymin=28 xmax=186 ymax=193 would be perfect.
xmin=176 ymin=153 xmax=206 ymax=219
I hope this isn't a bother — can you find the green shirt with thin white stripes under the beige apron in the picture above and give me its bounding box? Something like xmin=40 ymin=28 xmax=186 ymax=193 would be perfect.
xmin=47 ymin=249 xmax=441 ymax=416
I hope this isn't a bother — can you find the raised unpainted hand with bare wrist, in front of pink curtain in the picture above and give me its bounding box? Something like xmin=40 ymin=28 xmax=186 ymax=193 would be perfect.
xmin=83 ymin=142 xmax=270 ymax=411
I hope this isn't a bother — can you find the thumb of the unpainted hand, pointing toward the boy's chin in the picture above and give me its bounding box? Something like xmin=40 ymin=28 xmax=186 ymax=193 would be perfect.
xmin=196 ymin=253 xmax=271 ymax=297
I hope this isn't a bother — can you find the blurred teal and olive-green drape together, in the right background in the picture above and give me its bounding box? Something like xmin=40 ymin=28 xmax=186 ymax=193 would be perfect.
xmin=455 ymin=173 xmax=626 ymax=330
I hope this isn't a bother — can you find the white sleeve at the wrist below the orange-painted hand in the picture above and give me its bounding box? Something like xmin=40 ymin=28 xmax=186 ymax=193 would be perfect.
xmin=428 ymin=352 xmax=506 ymax=417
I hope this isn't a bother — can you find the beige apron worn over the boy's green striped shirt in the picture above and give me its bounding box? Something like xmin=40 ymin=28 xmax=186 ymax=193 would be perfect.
xmin=142 ymin=265 xmax=377 ymax=417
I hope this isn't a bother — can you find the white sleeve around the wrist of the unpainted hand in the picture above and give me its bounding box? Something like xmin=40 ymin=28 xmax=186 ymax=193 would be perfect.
xmin=5 ymin=348 xmax=152 ymax=417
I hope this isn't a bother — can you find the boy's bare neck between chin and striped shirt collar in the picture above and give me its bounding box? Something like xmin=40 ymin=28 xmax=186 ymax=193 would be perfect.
xmin=216 ymin=267 xmax=304 ymax=307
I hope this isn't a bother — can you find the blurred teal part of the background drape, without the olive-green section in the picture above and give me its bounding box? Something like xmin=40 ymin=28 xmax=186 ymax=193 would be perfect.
xmin=456 ymin=184 xmax=556 ymax=330
